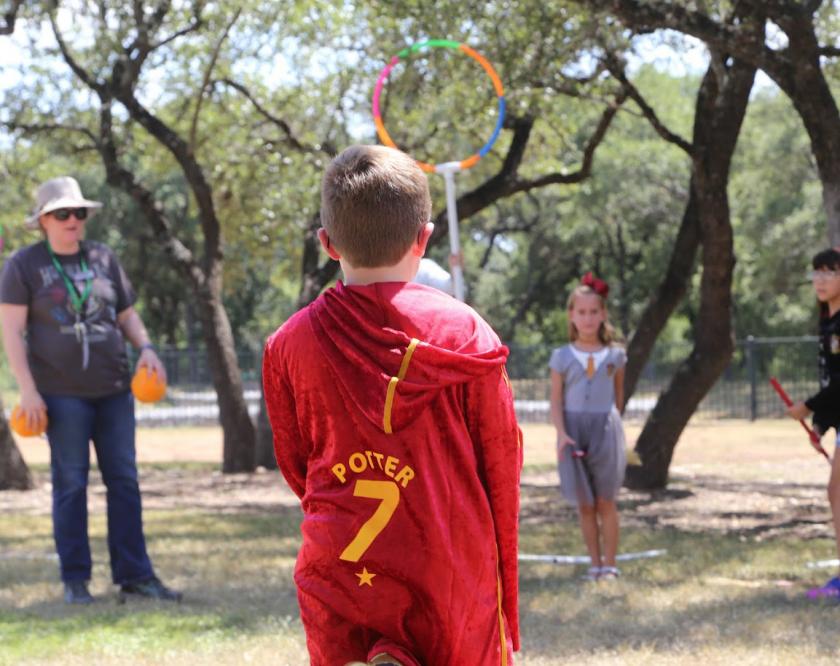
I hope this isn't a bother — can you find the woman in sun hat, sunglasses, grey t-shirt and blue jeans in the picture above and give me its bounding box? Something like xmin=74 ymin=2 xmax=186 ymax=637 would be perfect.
xmin=0 ymin=176 xmax=180 ymax=603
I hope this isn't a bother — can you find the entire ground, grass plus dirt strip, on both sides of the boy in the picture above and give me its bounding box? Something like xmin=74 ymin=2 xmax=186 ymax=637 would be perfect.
xmin=0 ymin=421 xmax=840 ymax=666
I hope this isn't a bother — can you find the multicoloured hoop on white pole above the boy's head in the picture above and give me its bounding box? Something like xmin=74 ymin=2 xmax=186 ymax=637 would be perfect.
xmin=373 ymin=39 xmax=505 ymax=301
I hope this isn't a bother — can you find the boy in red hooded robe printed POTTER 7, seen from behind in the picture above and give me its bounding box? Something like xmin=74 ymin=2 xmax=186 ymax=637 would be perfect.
xmin=263 ymin=146 xmax=522 ymax=666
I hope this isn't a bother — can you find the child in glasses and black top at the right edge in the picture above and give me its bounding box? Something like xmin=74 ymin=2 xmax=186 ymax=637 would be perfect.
xmin=788 ymin=248 xmax=840 ymax=599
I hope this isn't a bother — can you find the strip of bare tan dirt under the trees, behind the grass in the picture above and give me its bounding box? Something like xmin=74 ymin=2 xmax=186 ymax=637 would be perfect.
xmin=0 ymin=421 xmax=833 ymax=539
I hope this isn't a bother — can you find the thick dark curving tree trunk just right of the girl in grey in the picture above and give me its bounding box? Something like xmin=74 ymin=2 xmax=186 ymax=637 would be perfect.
xmin=625 ymin=48 xmax=763 ymax=490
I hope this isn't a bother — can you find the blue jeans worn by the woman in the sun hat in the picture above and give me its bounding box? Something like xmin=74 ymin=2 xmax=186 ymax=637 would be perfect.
xmin=43 ymin=391 xmax=154 ymax=585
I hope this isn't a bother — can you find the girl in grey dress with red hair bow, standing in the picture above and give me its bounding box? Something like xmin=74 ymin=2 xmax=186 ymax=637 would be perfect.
xmin=549 ymin=273 xmax=627 ymax=580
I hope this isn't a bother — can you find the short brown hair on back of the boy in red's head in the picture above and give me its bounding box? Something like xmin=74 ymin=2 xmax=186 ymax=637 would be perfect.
xmin=321 ymin=146 xmax=432 ymax=268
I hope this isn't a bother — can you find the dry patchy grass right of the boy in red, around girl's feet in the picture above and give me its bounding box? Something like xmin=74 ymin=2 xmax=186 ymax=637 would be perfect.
xmin=520 ymin=525 xmax=840 ymax=664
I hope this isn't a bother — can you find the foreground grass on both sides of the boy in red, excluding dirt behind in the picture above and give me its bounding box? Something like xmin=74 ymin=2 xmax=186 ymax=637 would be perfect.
xmin=6 ymin=498 xmax=840 ymax=666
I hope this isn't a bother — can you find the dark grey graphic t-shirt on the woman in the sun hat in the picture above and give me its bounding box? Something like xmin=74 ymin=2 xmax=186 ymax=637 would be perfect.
xmin=0 ymin=241 xmax=135 ymax=398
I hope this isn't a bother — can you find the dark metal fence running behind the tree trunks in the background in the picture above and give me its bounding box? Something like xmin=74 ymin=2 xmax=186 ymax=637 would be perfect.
xmin=137 ymin=337 xmax=817 ymax=426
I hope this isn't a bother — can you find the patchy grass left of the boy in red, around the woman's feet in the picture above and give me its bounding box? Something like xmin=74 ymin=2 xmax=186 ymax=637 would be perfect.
xmin=0 ymin=510 xmax=306 ymax=664
